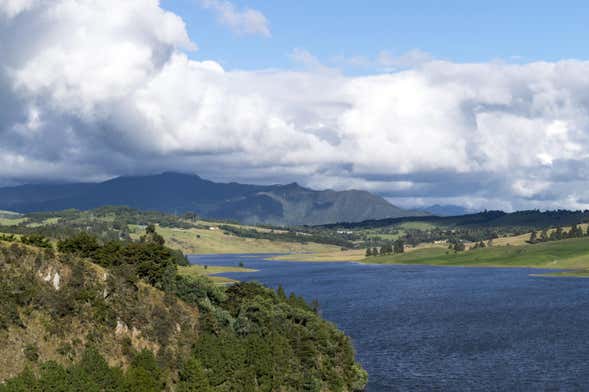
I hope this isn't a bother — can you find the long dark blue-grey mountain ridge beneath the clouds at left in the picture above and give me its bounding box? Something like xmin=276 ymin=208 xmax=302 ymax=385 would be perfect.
xmin=0 ymin=173 xmax=427 ymax=225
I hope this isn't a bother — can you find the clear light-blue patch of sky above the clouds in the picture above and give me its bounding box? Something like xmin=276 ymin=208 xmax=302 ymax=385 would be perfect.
xmin=162 ymin=0 xmax=589 ymax=72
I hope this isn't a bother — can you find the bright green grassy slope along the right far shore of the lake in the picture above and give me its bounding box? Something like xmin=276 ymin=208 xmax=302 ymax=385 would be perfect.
xmin=363 ymin=238 xmax=589 ymax=270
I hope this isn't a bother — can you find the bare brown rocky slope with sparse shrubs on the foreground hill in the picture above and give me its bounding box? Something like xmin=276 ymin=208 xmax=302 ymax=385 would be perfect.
xmin=0 ymin=241 xmax=199 ymax=383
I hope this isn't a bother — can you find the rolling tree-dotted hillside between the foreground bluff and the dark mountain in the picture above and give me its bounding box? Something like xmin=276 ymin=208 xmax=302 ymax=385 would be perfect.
xmin=0 ymin=207 xmax=349 ymax=254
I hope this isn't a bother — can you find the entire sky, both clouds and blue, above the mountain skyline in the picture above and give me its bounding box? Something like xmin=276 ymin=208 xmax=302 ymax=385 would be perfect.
xmin=0 ymin=0 xmax=589 ymax=211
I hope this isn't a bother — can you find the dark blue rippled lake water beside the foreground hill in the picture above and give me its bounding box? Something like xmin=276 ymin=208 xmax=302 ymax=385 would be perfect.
xmin=191 ymin=255 xmax=589 ymax=392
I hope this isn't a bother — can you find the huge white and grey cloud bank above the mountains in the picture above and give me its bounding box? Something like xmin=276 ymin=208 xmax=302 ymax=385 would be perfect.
xmin=0 ymin=0 xmax=589 ymax=209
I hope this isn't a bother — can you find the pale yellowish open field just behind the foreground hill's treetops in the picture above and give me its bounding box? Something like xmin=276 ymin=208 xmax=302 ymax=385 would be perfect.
xmin=130 ymin=226 xmax=339 ymax=254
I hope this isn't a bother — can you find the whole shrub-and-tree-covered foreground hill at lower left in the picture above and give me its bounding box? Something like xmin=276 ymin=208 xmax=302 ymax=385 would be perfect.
xmin=0 ymin=226 xmax=366 ymax=391
